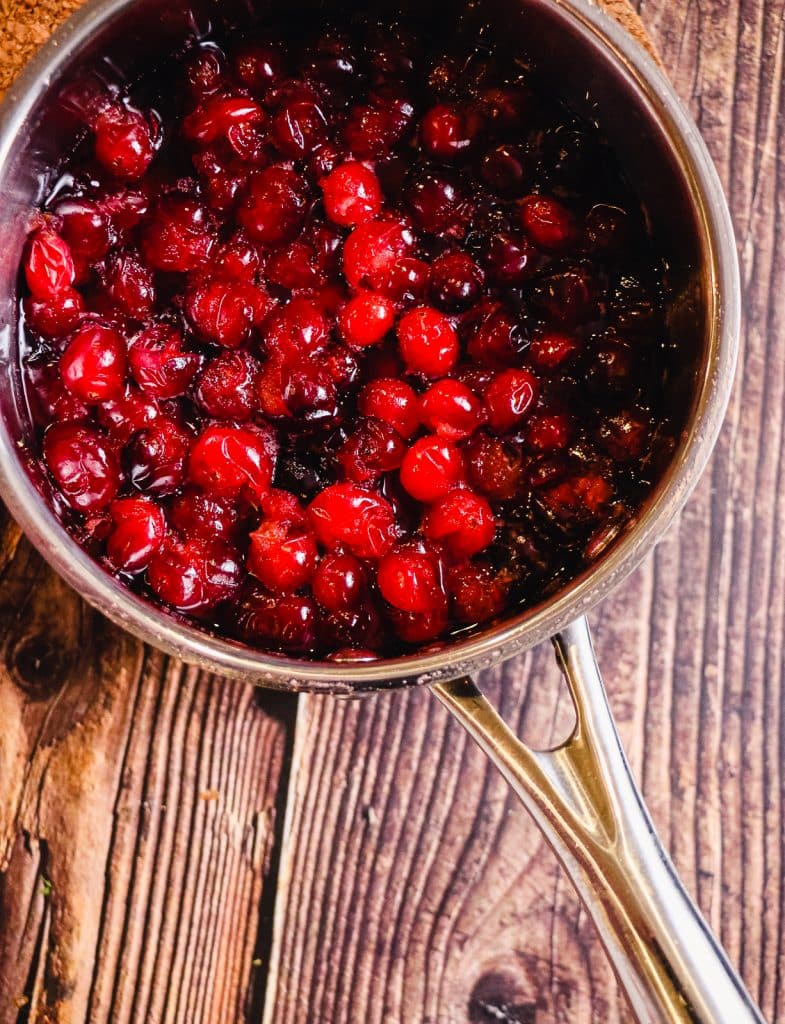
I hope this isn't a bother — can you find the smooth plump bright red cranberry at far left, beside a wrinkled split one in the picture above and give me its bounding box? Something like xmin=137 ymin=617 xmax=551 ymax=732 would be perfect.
xmin=60 ymin=324 xmax=126 ymax=404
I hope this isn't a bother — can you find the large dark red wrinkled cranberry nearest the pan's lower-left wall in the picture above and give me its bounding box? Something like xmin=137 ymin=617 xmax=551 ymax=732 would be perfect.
xmin=43 ymin=423 xmax=120 ymax=513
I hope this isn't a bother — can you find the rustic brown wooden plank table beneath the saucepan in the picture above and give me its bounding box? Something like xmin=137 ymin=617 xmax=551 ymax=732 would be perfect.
xmin=0 ymin=0 xmax=785 ymax=1024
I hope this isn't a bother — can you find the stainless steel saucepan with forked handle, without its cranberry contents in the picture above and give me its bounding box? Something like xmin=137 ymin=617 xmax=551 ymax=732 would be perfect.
xmin=0 ymin=0 xmax=762 ymax=1024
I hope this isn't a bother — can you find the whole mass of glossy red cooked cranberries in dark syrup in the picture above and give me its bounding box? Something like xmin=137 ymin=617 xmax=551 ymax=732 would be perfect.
xmin=21 ymin=12 xmax=673 ymax=660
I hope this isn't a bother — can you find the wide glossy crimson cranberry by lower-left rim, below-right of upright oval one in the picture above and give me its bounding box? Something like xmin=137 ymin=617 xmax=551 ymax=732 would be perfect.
xmin=147 ymin=537 xmax=243 ymax=613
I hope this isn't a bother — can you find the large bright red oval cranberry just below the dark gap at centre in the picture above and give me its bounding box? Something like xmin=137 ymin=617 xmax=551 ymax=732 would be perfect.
xmin=308 ymin=483 xmax=396 ymax=559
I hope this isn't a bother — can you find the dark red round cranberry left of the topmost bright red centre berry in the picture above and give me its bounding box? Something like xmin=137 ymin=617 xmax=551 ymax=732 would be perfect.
xmin=237 ymin=167 xmax=307 ymax=246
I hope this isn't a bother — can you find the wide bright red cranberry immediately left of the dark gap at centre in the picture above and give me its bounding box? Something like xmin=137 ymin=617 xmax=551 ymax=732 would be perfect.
xmin=188 ymin=427 xmax=273 ymax=498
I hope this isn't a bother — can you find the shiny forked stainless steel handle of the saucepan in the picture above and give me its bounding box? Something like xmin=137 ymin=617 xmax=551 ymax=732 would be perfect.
xmin=433 ymin=618 xmax=764 ymax=1024
